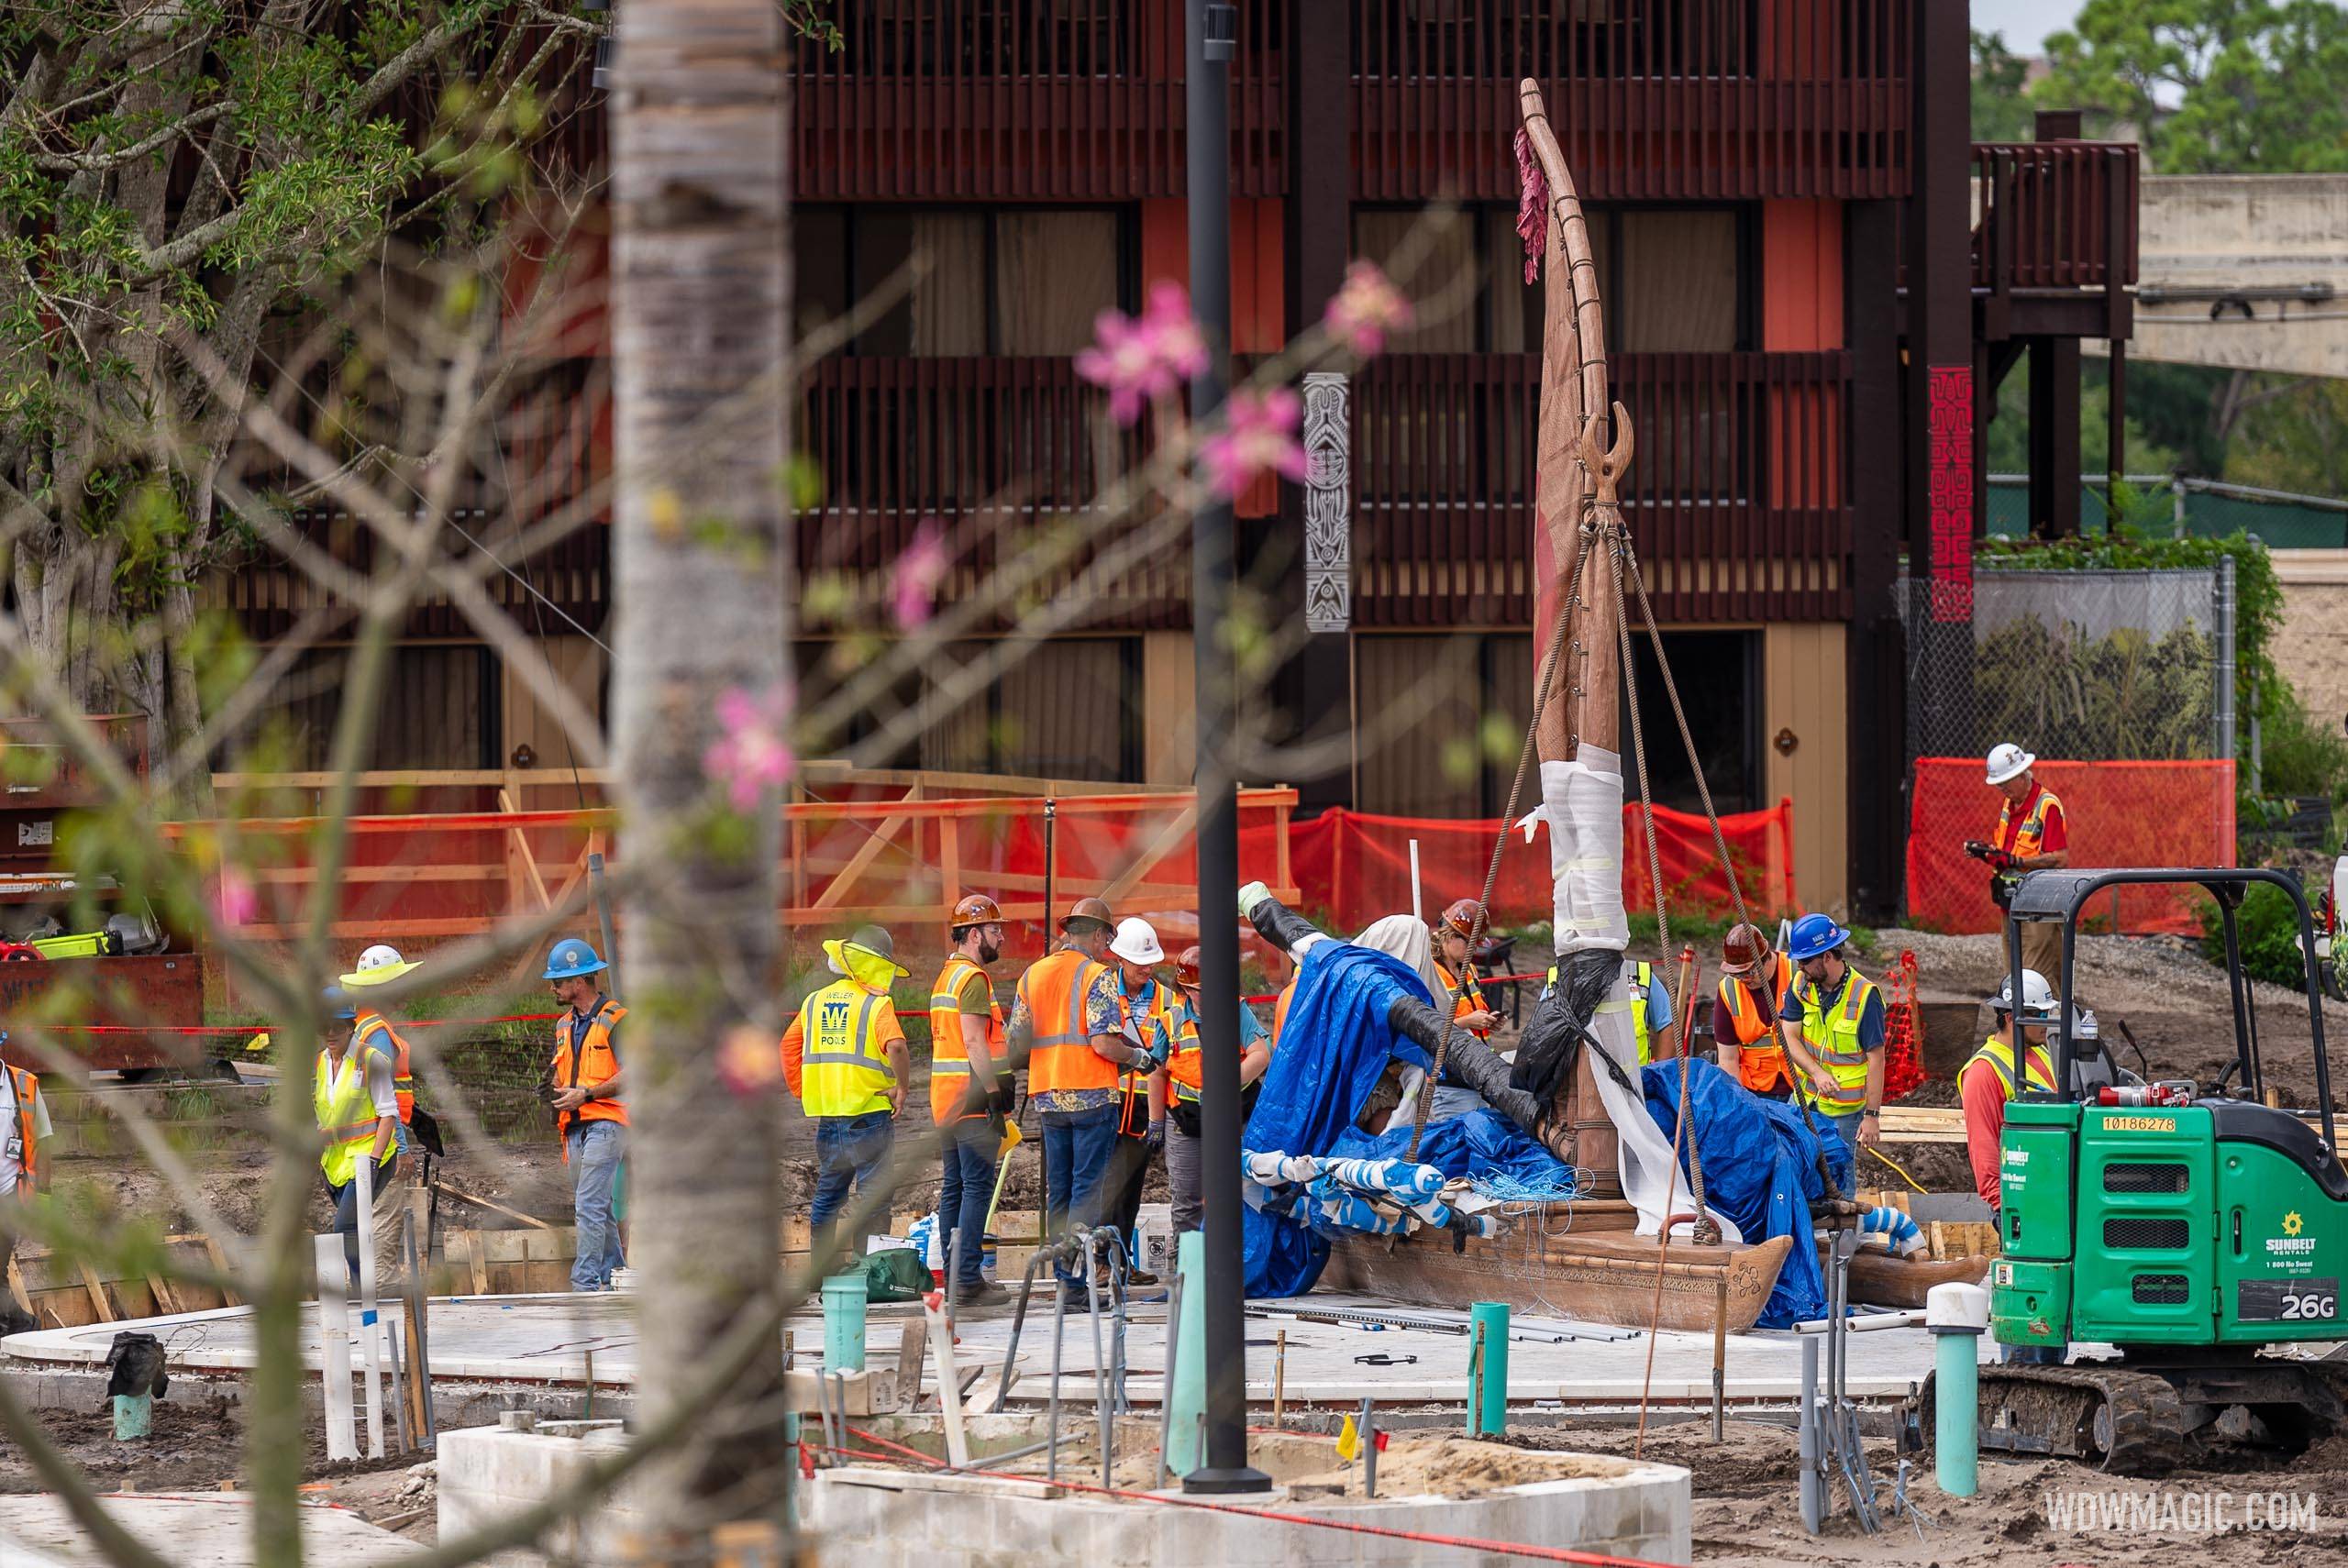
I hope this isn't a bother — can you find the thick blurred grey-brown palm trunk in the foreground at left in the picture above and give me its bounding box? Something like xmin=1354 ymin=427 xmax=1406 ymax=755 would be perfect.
xmin=613 ymin=0 xmax=789 ymax=1533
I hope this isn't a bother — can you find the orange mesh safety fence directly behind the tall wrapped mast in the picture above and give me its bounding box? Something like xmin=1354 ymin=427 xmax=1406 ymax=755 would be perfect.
xmin=1286 ymin=801 xmax=1799 ymax=932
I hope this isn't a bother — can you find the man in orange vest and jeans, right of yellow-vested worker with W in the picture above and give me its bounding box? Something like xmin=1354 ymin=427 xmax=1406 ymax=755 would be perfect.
xmin=930 ymin=892 xmax=1012 ymax=1305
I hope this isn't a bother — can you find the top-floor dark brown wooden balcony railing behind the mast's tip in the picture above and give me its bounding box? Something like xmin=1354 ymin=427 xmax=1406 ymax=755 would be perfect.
xmin=1353 ymin=0 xmax=1913 ymax=200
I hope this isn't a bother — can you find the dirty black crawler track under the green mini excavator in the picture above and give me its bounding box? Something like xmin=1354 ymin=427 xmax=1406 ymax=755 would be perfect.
xmin=1913 ymin=1364 xmax=2186 ymax=1476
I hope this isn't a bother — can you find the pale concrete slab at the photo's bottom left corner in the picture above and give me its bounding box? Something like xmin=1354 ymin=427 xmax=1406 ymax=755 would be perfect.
xmin=0 ymin=1493 xmax=423 ymax=1568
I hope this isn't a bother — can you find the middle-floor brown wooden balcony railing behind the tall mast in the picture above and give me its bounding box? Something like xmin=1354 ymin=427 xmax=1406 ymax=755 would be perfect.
xmin=1353 ymin=352 xmax=1850 ymax=626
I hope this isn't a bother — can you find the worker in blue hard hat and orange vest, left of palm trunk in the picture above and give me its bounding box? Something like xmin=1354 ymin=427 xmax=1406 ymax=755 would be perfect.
xmin=547 ymin=936 xmax=627 ymax=1291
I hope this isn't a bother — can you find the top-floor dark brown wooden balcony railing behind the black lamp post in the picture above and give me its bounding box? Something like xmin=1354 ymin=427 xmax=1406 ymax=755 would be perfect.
xmin=792 ymin=0 xmax=1289 ymax=202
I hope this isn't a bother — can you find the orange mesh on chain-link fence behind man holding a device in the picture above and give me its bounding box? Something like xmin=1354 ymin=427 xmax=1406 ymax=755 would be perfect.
xmin=1907 ymin=756 xmax=2233 ymax=934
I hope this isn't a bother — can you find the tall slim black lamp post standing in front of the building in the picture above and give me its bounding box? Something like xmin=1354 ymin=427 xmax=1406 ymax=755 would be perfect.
xmin=1181 ymin=0 xmax=1273 ymax=1493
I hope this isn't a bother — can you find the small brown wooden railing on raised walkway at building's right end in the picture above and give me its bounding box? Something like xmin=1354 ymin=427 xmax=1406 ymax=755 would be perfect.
xmin=1972 ymin=141 xmax=2142 ymax=293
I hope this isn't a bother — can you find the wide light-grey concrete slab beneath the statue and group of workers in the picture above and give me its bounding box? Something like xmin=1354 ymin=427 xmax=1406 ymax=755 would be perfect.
xmin=0 ymin=1293 xmax=1996 ymax=1408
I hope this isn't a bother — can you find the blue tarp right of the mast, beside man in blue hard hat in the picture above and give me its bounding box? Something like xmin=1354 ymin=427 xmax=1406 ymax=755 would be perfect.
xmin=1644 ymin=1061 xmax=1850 ymax=1329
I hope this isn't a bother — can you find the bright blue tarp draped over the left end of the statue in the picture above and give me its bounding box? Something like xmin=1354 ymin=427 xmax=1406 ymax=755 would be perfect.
xmin=1240 ymin=942 xmax=1434 ymax=1296
